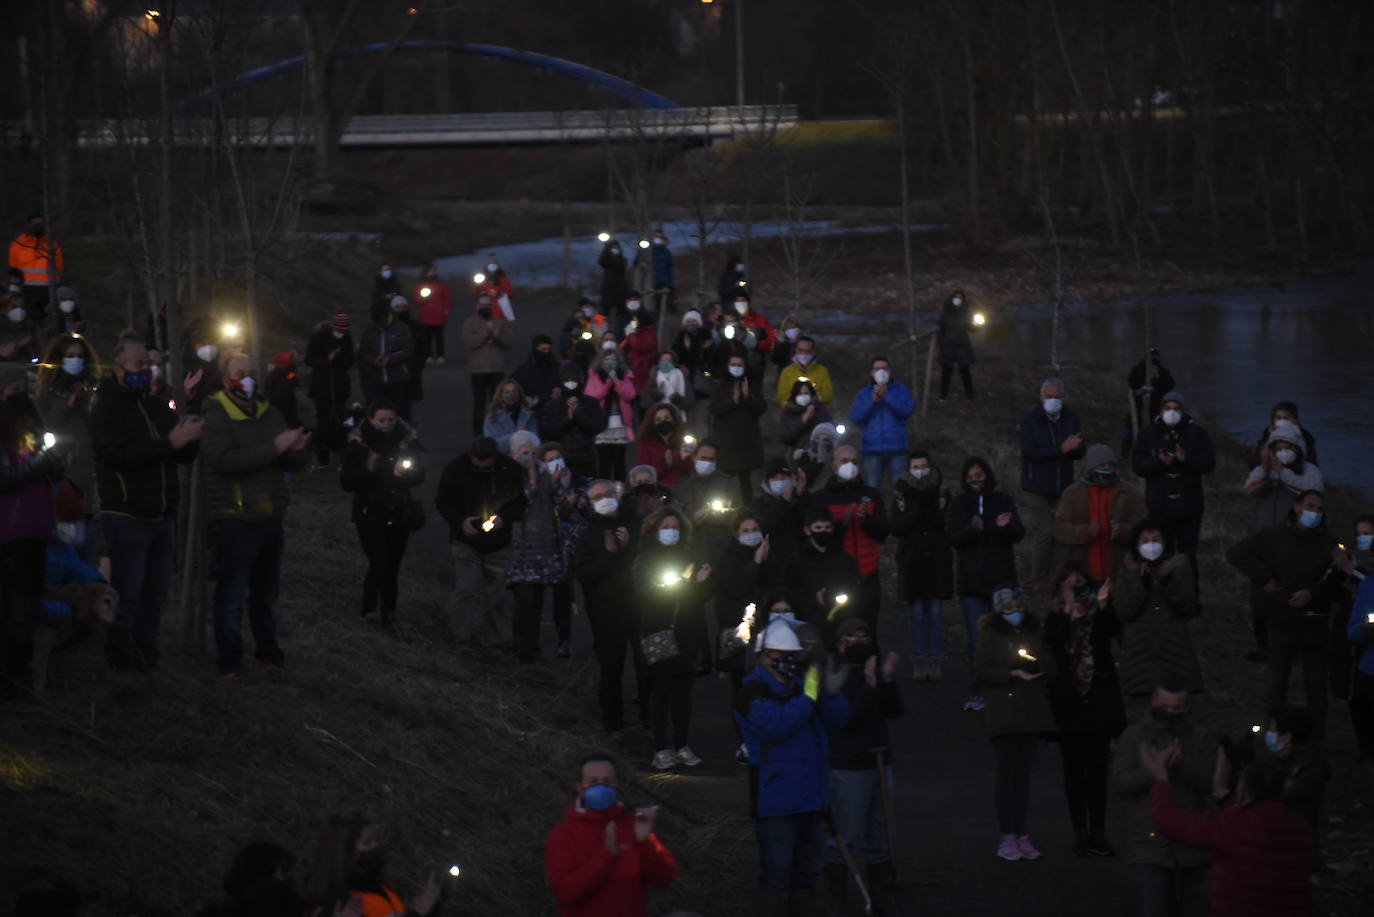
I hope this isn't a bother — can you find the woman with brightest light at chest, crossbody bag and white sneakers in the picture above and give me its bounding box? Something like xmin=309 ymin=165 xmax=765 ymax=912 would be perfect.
xmin=632 ymin=506 xmax=716 ymax=770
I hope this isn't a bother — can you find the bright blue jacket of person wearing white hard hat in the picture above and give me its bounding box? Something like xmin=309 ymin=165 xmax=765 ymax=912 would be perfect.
xmin=735 ymin=667 xmax=849 ymax=818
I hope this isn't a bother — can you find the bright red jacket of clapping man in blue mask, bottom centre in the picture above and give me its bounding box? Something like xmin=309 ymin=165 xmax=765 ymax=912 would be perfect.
xmin=544 ymin=804 xmax=677 ymax=917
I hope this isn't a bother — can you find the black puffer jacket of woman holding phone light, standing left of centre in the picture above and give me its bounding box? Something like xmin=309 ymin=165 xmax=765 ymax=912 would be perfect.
xmin=339 ymin=419 xmax=425 ymax=525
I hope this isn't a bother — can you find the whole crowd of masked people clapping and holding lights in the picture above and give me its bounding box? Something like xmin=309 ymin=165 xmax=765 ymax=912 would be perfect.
xmin=0 ymin=217 xmax=1374 ymax=917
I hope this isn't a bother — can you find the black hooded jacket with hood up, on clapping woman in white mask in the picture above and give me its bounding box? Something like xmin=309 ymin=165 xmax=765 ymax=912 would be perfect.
xmin=945 ymin=458 xmax=1026 ymax=595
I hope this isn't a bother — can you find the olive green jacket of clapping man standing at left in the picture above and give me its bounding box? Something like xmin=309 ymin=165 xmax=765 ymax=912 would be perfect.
xmin=201 ymin=390 xmax=306 ymax=522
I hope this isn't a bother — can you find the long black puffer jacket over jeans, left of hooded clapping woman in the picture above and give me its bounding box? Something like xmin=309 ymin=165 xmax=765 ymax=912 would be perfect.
xmin=890 ymin=469 xmax=954 ymax=602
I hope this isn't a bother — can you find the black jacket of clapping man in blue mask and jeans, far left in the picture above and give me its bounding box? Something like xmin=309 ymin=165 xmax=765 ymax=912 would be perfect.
xmin=91 ymin=378 xmax=199 ymax=520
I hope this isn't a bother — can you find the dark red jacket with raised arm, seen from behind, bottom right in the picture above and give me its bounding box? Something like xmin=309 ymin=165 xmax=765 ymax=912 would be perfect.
xmin=1150 ymin=781 xmax=1312 ymax=917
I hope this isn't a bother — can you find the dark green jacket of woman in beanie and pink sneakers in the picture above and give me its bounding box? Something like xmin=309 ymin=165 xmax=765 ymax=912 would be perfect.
xmin=973 ymin=612 xmax=1058 ymax=738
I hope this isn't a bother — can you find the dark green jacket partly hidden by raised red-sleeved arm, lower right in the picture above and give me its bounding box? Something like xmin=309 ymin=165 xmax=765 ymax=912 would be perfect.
xmin=1112 ymin=711 xmax=1217 ymax=869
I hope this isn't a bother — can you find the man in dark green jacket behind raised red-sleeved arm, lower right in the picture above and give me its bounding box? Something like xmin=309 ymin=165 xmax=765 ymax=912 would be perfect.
xmin=1112 ymin=683 xmax=1226 ymax=917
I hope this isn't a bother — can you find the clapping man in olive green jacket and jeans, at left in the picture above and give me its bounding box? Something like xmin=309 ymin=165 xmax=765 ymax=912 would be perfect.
xmin=201 ymin=355 xmax=311 ymax=678
